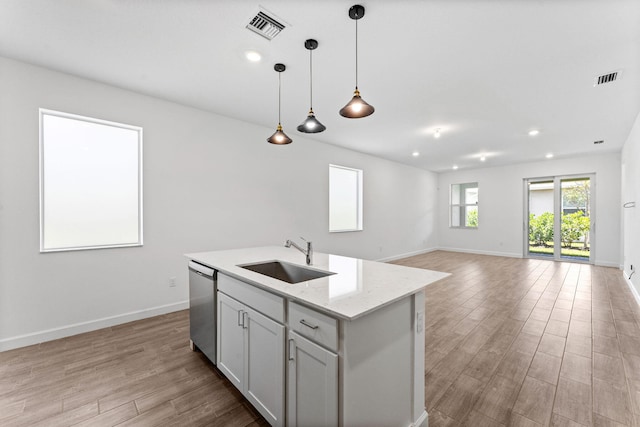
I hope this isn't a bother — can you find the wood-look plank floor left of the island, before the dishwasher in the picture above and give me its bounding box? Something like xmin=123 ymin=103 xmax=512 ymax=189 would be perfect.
xmin=0 ymin=310 xmax=268 ymax=427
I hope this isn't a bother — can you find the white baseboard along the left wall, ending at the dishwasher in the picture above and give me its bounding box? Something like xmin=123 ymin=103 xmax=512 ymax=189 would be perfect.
xmin=0 ymin=301 xmax=189 ymax=351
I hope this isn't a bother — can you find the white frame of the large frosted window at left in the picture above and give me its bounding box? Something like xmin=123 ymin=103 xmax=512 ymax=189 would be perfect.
xmin=38 ymin=108 xmax=144 ymax=253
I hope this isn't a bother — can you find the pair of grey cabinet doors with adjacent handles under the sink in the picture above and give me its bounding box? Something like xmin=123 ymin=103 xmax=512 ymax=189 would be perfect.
xmin=217 ymin=287 xmax=285 ymax=426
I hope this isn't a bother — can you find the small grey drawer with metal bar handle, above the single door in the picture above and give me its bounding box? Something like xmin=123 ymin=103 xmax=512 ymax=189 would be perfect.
xmin=289 ymin=302 xmax=338 ymax=351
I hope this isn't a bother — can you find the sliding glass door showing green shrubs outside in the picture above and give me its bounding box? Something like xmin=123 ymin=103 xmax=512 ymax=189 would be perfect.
xmin=525 ymin=175 xmax=595 ymax=263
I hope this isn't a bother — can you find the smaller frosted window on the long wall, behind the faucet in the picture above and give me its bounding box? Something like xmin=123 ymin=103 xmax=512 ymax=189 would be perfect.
xmin=329 ymin=165 xmax=362 ymax=232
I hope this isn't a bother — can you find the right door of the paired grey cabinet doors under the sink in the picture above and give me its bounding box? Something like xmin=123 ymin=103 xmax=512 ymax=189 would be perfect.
xmin=243 ymin=308 xmax=285 ymax=426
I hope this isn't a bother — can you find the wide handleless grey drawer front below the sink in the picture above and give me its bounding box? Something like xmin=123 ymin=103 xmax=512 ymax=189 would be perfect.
xmin=218 ymin=273 xmax=284 ymax=323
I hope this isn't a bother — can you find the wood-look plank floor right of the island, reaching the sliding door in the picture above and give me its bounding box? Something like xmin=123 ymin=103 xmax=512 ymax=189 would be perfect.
xmin=397 ymin=252 xmax=640 ymax=427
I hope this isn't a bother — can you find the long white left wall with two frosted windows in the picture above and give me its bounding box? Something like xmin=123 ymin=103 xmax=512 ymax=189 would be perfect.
xmin=0 ymin=58 xmax=437 ymax=350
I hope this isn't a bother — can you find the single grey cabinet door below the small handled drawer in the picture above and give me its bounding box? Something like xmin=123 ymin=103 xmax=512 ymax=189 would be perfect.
xmin=287 ymin=331 xmax=338 ymax=427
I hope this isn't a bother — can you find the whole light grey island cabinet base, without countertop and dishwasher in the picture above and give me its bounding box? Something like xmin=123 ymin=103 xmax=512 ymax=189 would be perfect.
xmin=212 ymin=273 xmax=428 ymax=427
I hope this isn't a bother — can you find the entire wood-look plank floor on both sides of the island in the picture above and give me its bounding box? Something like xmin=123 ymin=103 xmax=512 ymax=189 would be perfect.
xmin=0 ymin=252 xmax=640 ymax=427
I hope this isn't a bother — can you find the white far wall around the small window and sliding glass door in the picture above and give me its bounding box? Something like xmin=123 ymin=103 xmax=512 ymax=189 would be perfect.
xmin=438 ymin=153 xmax=621 ymax=267
